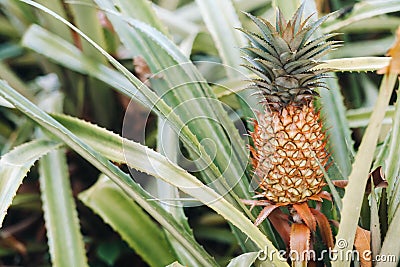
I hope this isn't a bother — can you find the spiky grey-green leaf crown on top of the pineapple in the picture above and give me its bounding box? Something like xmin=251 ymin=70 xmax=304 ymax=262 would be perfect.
xmin=239 ymin=4 xmax=340 ymax=109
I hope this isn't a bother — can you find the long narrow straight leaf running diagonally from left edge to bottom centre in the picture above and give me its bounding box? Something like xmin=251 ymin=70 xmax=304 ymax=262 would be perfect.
xmin=0 ymin=81 xmax=216 ymax=266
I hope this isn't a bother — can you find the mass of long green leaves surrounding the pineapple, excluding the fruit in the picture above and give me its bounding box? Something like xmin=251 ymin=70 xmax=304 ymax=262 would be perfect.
xmin=0 ymin=0 xmax=400 ymax=266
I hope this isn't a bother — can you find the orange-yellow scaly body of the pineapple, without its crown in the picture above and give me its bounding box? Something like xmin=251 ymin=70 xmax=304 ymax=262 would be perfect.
xmin=250 ymin=101 xmax=329 ymax=205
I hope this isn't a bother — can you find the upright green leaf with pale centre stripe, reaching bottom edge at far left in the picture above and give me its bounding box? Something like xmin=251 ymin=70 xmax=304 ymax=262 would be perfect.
xmin=36 ymin=91 xmax=88 ymax=267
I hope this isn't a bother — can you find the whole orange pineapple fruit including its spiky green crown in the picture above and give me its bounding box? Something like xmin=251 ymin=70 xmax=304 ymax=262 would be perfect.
xmin=241 ymin=5 xmax=338 ymax=205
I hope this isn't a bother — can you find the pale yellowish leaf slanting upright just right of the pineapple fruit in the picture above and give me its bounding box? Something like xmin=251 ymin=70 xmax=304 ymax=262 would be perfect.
xmin=332 ymin=74 xmax=397 ymax=267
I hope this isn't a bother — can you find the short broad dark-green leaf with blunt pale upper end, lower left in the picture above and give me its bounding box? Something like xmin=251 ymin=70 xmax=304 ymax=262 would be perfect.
xmin=79 ymin=175 xmax=175 ymax=266
